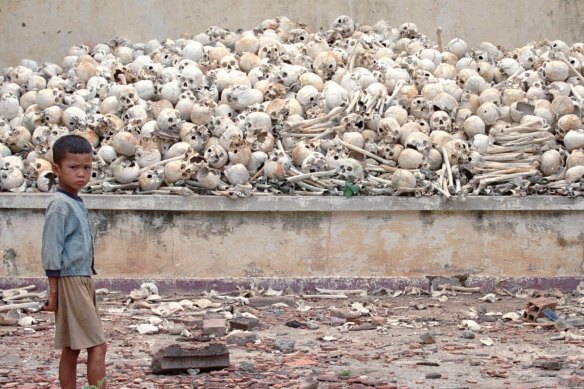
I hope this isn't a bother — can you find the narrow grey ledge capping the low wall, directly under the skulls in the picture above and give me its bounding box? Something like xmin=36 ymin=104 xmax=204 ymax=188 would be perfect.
xmin=0 ymin=193 xmax=584 ymax=212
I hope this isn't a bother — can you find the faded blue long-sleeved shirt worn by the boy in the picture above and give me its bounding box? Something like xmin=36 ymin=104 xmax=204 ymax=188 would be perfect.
xmin=41 ymin=191 xmax=96 ymax=277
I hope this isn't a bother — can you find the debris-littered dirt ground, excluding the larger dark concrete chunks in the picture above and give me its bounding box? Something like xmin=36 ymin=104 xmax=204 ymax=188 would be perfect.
xmin=0 ymin=289 xmax=584 ymax=388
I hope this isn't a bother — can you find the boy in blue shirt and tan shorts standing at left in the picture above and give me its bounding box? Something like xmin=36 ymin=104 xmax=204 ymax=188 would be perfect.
xmin=41 ymin=135 xmax=106 ymax=389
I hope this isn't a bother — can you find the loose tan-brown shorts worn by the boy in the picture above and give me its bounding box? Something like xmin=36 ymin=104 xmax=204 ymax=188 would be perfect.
xmin=55 ymin=277 xmax=105 ymax=350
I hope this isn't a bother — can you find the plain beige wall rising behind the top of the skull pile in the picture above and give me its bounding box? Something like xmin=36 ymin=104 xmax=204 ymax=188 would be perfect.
xmin=0 ymin=0 xmax=584 ymax=67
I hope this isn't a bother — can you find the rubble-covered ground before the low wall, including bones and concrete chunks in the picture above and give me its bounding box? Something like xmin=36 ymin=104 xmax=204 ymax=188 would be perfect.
xmin=0 ymin=283 xmax=584 ymax=389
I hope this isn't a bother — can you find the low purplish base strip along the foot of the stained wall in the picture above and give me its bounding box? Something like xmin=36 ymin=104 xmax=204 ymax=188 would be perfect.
xmin=0 ymin=276 xmax=584 ymax=294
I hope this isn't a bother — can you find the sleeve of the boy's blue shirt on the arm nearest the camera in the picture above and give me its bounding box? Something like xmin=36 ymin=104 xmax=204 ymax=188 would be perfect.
xmin=41 ymin=205 xmax=67 ymax=277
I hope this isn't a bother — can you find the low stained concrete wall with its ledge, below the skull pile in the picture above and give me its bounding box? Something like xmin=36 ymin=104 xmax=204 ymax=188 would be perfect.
xmin=0 ymin=194 xmax=584 ymax=286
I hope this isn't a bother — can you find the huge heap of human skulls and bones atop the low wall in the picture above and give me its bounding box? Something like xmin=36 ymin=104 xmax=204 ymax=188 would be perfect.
xmin=0 ymin=16 xmax=584 ymax=197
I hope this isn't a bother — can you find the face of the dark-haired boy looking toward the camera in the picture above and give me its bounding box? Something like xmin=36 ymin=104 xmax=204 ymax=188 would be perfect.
xmin=53 ymin=152 xmax=92 ymax=196
